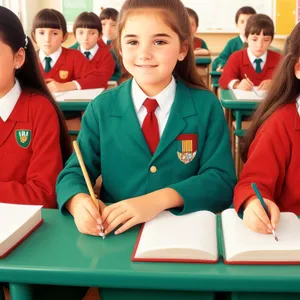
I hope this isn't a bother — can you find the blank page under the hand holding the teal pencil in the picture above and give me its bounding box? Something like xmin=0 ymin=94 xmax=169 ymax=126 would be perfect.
xmin=222 ymin=209 xmax=300 ymax=261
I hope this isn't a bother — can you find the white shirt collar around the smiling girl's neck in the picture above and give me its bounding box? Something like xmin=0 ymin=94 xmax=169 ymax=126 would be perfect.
xmin=131 ymin=76 xmax=176 ymax=115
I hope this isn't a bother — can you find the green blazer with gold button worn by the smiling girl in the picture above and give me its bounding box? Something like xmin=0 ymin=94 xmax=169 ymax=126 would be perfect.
xmin=56 ymin=79 xmax=236 ymax=214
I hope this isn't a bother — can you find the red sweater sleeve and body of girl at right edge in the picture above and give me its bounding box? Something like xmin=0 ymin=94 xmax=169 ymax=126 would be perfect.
xmin=234 ymin=102 xmax=300 ymax=215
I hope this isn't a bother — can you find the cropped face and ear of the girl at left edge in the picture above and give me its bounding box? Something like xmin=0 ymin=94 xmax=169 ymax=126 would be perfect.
xmin=0 ymin=40 xmax=25 ymax=98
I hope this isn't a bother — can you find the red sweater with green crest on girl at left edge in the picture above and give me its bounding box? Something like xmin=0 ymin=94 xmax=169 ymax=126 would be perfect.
xmin=0 ymin=92 xmax=63 ymax=208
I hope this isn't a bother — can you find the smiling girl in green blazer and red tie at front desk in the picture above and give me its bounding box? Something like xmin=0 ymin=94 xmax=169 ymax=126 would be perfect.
xmin=57 ymin=0 xmax=236 ymax=235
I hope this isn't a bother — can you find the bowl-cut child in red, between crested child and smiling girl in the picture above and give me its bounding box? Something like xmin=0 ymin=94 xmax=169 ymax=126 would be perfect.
xmin=73 ymin=12 xmax=116 ymax=86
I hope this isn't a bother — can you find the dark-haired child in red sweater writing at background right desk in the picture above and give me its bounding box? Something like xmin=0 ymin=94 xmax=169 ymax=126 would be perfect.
xmin=219 ymin=14 xmax=281 ymax=90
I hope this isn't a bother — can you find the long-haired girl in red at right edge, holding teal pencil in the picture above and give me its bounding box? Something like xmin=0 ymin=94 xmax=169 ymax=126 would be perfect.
xmin=234 ymin=23 xmax=300 ymax=233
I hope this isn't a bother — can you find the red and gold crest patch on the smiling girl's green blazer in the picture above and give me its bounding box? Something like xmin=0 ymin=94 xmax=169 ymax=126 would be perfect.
xmin=176 ymin=134 xmax=198 ymax=164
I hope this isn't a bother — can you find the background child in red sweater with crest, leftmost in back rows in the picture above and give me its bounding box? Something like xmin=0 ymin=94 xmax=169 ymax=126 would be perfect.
xmin=32 ymin=9 xmax=102 ymax=92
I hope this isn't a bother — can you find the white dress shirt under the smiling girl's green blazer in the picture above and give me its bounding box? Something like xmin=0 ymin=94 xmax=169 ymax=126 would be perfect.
xmin=131 ymin=76 xmax=176 ymax=137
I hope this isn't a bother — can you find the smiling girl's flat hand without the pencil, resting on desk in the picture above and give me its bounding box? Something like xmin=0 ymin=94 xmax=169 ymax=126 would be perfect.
xmin=102 ymin=193 xmax=164 ymax=234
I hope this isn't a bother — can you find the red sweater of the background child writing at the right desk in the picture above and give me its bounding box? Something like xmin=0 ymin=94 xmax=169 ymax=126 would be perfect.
xmin=219 ymin=49 xmax=281 ymax=89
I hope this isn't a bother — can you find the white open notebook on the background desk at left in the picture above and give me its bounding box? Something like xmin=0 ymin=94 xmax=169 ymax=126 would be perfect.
xmin=53 ymin=88 xmax=104 ymax=102
